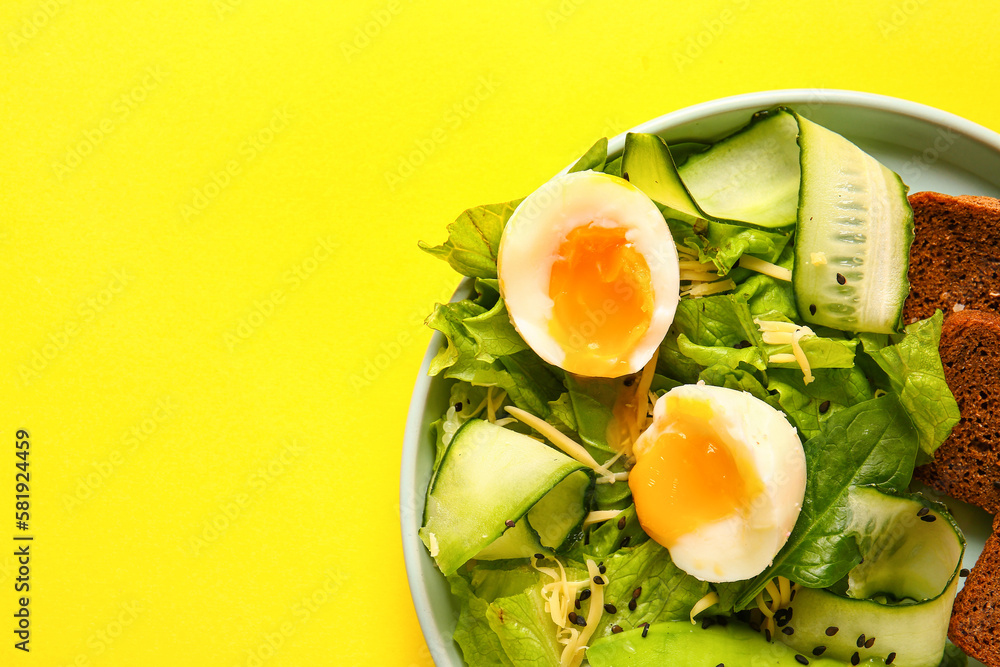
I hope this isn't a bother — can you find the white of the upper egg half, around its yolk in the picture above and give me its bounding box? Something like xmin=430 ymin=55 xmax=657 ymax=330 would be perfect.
xmin=497 ymin=171 xmax=680 ymax=375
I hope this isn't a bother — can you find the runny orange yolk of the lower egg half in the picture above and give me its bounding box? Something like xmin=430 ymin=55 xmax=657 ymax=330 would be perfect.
xmin=628 ymin=400 xmax=763 ymax=549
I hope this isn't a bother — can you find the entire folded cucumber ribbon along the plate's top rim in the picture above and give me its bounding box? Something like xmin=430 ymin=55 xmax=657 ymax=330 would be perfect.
xmin=622 ymin=108 xmax=913 ymax=333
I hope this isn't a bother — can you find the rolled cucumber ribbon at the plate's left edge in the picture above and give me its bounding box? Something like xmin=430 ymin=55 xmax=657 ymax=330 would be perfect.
xmin=420 ymin=419 xmax=595 ymax=575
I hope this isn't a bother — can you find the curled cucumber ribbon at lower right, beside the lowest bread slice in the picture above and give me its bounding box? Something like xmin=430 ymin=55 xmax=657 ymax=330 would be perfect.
xmin=777 ymin=487 xmax=965 ymax=667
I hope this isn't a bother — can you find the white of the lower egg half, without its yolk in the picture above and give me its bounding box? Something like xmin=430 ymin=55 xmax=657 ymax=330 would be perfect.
xmin=635 ymin=384 xmax=806 ymax=582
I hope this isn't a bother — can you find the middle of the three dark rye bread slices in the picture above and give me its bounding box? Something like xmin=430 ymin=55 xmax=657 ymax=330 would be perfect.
xmin=915 ymin=309 xmax=1000 ymax=514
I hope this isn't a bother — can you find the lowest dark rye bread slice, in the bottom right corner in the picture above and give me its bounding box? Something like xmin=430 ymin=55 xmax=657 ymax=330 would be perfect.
xmin=948 ymin=515 xmax=1000 ymax=667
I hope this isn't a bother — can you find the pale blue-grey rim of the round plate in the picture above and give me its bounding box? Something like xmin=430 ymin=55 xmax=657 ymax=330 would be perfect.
xmin=399 ymin=88 xmax=1000 ymax=665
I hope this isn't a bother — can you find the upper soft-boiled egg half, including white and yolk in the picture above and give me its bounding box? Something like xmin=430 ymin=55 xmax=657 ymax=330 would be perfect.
xmin=497 ymin=171 xmax=680 ymax=377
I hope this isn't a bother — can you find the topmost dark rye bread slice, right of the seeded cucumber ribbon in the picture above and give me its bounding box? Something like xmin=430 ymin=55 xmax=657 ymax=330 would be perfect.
xmin=903 ymin=192 xmax=1000 ymax=323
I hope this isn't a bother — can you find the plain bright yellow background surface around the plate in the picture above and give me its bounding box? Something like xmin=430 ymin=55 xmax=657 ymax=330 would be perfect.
xmin=0 ymin=0 xmax=1000 ymax=666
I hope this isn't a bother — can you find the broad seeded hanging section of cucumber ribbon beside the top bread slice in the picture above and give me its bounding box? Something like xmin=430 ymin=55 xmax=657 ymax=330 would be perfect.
xmin=792 ymin=117 xmax=913 ymax=333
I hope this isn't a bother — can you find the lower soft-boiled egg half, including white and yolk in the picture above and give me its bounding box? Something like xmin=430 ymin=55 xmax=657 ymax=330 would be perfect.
xmin=628 ymin=384 xmax=806 ymax=582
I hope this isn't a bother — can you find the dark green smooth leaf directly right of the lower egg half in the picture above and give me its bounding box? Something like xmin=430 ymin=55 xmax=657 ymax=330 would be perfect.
xmin=716 ymin=395 xmax=917 ymax=610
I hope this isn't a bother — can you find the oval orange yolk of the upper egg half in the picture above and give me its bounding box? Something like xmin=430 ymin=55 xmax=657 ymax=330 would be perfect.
xmin=549 ymin=223 xmax=653 ymax=377
